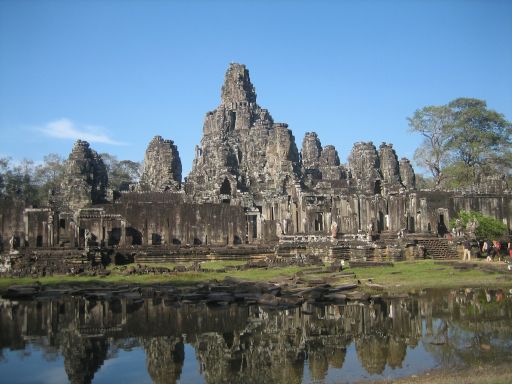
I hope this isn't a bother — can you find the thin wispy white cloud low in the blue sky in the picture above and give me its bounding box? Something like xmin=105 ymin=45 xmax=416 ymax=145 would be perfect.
xmin=41 ymin=118 xmax=125 ymax=145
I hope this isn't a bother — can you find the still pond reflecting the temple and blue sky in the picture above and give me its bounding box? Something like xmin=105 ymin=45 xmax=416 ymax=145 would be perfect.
xmin=0 ymin=290 xmax=512 ymax=384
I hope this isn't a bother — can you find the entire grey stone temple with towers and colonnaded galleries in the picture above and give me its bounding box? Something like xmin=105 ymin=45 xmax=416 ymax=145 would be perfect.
xmin=0 ymin=64 xmax=512 ymax=268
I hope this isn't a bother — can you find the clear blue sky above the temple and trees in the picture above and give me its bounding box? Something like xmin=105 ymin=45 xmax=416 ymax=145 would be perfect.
xmin=0 ymin=0 xmax=512 ymax=176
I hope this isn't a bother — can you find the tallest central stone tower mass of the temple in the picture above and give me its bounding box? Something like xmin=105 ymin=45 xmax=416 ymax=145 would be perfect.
xmin=185 ymin=64 xmax=300 ymax=202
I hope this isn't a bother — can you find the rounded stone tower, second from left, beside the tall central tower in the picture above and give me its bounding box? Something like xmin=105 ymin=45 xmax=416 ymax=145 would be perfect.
xmin=140 ymin=136 xmax=181 ymax=192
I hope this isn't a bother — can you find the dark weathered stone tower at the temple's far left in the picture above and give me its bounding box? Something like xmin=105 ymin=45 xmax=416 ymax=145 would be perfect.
xmin=61 ymin=140 xmax=108 ymax=210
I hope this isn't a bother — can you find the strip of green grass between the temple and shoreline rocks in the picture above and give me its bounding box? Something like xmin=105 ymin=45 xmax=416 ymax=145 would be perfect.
xmin=0 ymin=260 xmax=512 ymax=292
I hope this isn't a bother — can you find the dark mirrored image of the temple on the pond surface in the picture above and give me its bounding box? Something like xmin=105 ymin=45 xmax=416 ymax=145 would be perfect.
xmin=0 ymin=291 xmax=512 ymax=383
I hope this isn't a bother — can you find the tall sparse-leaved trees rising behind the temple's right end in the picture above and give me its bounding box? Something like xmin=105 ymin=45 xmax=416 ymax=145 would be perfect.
xmin=408 ymin=98 xmax=512 ymax=188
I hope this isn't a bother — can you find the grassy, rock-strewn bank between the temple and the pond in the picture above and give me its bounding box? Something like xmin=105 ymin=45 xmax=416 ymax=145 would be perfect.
xmin=0 ymin=260 xmax=512 ymax=308
